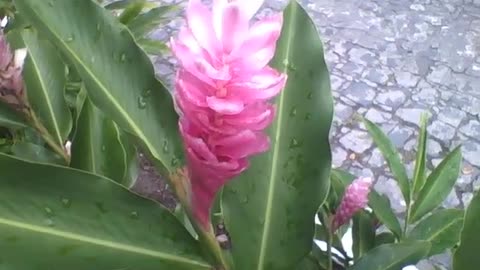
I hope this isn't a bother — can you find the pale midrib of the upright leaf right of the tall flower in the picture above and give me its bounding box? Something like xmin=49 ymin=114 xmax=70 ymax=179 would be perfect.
xmin=257 ymin=5 xmax=296 ymax=270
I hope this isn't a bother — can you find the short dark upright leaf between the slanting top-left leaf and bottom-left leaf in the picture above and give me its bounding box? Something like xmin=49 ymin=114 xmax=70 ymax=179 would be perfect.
xmin=71 ymin=99 xmax=136 ymax=187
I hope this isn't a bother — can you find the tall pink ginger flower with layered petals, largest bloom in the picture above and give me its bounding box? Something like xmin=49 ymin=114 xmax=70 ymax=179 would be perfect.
xmin=171 ymin=0 xmax=287 ymax=228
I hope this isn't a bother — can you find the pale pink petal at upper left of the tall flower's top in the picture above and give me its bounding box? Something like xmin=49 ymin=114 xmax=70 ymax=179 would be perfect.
xmin=186 ymin=0 xmax=218 ymax=56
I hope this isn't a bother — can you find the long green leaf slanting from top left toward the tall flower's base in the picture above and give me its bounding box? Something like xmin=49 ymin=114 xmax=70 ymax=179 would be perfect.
xmin=15 ymin=0 xmax=183 ymax=173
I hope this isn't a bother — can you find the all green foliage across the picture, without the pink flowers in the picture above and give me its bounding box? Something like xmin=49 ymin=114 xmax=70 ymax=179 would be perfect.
xmin=0 ymin=0 xmax=472 ymax=270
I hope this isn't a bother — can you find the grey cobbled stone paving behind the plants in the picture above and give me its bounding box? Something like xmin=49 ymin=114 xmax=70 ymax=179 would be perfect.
xmin=153 ymin=0 xmax=480 ymax=270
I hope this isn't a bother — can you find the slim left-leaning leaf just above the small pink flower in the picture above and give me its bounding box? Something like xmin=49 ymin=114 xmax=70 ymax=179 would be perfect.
xmin=363 ymin=119 xmax=410 ymax=205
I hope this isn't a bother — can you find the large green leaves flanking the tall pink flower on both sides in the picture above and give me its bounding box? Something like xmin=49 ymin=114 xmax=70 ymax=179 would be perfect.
xmin=0 ymin=0 xmax=333 ymax=270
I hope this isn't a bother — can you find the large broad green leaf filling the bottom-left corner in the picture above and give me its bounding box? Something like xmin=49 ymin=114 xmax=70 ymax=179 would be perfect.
xmin=0 ymin=154 xmax=211 ymax=270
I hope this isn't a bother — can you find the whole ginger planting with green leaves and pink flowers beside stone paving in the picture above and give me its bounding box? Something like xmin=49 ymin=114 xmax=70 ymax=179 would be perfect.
xmin=0 ymin=0 xmax=472 ymax=270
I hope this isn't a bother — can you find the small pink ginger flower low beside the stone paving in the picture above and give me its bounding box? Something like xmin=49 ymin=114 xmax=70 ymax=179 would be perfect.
xmin=331 ymin=177 xmax=373 ymax=232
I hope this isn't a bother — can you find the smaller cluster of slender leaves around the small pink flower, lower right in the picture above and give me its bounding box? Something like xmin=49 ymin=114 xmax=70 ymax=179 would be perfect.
xmin=313 ymin=115 xmax=466 ymax=270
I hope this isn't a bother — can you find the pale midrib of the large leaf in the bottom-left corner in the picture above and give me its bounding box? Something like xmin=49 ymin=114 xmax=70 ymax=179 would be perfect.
xmin=0 ymin=218 xmax=210 ymax=269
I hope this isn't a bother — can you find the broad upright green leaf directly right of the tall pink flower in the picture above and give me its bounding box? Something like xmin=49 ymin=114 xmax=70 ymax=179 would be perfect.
xmin=222 ymin=1 xmax=333 ymax=270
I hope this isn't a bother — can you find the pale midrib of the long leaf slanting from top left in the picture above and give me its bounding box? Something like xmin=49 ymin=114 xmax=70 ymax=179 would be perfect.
xmin=21 ymin=5 xmax=161 ymax=164
